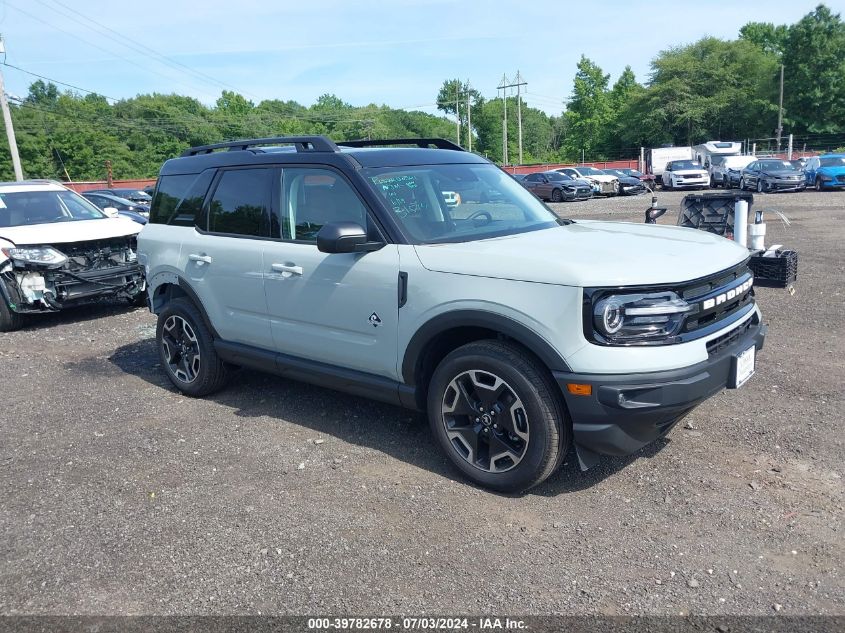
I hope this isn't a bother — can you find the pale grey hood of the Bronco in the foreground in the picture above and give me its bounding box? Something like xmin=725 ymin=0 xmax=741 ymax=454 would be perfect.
xmin=414 ymin=220 xmax=748 ymax=287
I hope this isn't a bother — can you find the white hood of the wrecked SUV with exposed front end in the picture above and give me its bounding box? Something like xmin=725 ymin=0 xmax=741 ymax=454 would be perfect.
xmin=0 ymin=217 xmax=141 ymax=246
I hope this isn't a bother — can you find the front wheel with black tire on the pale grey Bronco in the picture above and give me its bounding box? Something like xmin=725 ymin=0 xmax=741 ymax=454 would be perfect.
xmin=428 ymin=340 xmax=572 ymax=493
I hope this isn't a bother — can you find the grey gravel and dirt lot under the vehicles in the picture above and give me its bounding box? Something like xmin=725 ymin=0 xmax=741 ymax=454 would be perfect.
xmin=0 ymin=192 xmax=845 ymax=615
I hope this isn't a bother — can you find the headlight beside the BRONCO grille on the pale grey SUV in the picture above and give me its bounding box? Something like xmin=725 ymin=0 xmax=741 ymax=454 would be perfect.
xmin=585 ymin=291 xmax=694 ymax=345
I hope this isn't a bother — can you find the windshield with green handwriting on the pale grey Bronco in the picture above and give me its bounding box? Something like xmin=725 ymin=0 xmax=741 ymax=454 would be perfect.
xmin=364 ymin=164 xmax=565 ymax=244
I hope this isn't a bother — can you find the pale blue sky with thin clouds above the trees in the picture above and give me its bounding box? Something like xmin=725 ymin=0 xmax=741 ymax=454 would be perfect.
xmin=0 ymin=0 xmax=845 ymax=114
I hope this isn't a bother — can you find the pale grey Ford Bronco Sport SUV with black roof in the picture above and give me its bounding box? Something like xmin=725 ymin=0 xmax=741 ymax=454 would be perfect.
xmin=138 ymin=136 xmax=766 ymax=491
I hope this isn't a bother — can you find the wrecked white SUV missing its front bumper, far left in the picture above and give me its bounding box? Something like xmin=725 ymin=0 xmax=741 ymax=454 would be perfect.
xmin=0 ymin=180 xmax=146 ymax=332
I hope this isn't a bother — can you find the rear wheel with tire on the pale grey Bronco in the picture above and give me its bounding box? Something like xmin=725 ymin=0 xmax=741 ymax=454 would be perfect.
xmin=156 ymin=298 xmax=228 ymax=397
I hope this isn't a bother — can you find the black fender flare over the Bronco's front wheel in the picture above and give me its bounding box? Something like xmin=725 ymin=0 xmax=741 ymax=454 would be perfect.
xmin=402 ymin=310 xmax=569 ymax=386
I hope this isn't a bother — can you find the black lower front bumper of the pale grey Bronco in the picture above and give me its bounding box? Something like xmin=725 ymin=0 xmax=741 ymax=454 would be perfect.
xmin=554 ymin=318 xmax=767 ymax=470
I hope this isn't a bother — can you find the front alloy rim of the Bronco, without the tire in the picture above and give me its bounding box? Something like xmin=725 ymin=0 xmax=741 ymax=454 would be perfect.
xmin=440 ymin=370 xmax=529 ymax=473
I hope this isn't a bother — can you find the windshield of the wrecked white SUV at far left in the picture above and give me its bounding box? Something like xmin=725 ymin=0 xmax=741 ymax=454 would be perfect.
xmin=0 ymin=190 xmax=107 ymax=227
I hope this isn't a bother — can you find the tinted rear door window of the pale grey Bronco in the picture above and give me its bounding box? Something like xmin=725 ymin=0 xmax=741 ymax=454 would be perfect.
xmin=208 ymin=168 xmax=273 ymax=237
